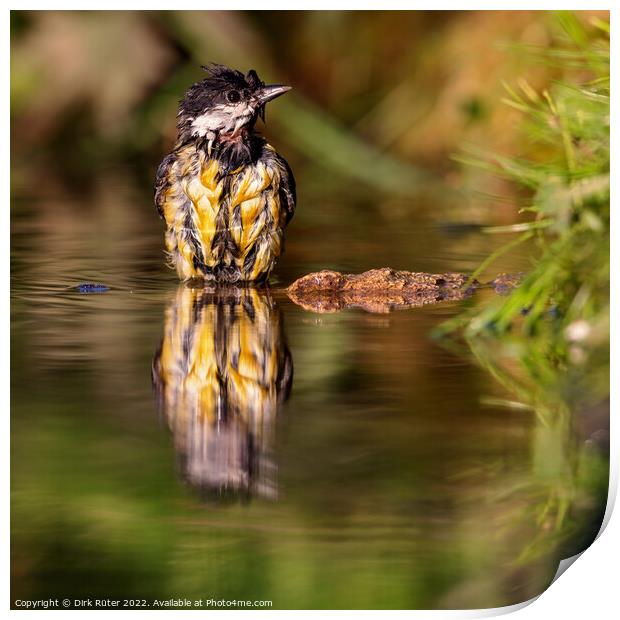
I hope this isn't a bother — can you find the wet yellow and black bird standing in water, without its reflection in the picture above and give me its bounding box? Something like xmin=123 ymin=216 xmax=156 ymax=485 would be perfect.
xmin=155 ymin=64 xmax=296 ymax=283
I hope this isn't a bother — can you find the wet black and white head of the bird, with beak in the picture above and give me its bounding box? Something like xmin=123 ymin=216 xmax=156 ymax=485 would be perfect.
xmin=178 ymin=64 xmax=291 ymax=141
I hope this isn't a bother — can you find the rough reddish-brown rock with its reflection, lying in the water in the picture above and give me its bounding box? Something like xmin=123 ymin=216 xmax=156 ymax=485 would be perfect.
xmin=286 ymin=267 xmax=479 ymax=312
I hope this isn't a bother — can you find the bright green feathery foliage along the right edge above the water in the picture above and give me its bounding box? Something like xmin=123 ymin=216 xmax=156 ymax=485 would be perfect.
xmin=444 ymin=13 xmax=610 ymax=404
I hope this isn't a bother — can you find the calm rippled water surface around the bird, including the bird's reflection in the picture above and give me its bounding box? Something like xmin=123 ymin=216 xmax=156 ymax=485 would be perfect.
xmin=11 ymin=174 xmax=607 ymax=609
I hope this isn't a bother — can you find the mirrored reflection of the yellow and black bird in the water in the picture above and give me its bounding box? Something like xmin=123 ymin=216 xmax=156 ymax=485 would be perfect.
xmin=153 ymin=285 xmax=293 ymax=498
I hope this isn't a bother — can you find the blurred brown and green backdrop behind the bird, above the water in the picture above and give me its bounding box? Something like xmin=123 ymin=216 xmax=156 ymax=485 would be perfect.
xmin=11 ymin=11 xmax=604 ymax=211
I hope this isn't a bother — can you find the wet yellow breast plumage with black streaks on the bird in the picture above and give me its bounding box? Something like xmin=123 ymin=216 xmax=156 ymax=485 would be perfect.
xmin=164 ymin=145 xmax=281 ymax=279
